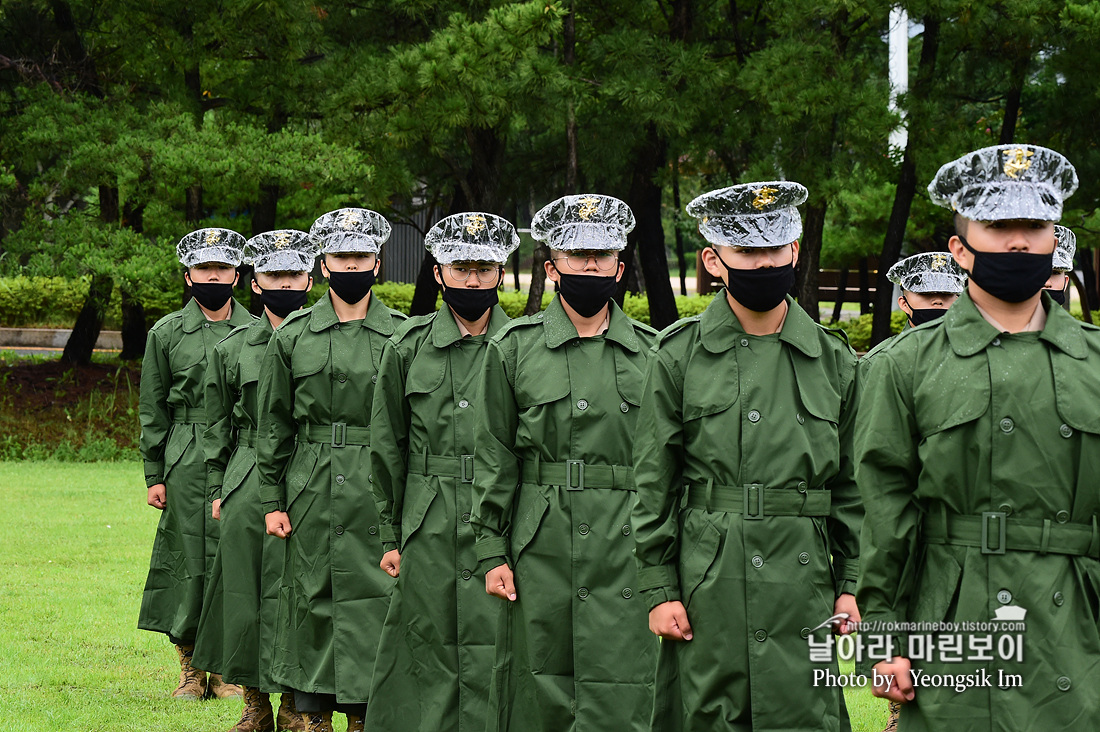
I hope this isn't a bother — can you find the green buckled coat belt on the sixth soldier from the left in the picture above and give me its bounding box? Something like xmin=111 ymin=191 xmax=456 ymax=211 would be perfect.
xmin=688 ymin=482 xmax=833 ymax=518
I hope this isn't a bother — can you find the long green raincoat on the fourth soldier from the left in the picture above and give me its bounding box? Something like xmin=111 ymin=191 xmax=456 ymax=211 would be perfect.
xmin=366 ymin=306 xmax=508 ymax=732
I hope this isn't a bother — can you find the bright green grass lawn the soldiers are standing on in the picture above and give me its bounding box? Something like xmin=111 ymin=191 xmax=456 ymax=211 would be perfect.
xmin=0 ymin=462 xmax=886 ymax=732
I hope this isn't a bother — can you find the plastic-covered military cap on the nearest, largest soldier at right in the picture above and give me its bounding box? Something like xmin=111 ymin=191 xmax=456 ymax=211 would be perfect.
xmin=928 ymin=145 xmax=1077 ymax=221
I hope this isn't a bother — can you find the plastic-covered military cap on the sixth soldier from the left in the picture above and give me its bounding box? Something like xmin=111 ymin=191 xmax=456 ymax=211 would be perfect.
xmin=688 ymin=181 xmax=809 ymax=247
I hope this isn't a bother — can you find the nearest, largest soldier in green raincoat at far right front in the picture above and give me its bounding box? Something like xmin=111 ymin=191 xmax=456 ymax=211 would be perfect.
xmin=856 ymin=145 xmax=1100 ymax=732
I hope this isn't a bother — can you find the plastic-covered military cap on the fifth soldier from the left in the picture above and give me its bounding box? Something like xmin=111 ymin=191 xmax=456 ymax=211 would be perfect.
xmin=531 ymin=194 xmax=634 ymax=252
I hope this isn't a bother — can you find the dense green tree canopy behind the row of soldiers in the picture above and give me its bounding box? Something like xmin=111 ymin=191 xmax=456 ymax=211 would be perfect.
xmin=0 ymin=0 xmax=1100 ymax=361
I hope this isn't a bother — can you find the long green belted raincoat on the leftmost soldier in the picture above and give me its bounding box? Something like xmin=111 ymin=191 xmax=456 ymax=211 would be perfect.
xmin=138 ymin=299 xmax=254 ymax=645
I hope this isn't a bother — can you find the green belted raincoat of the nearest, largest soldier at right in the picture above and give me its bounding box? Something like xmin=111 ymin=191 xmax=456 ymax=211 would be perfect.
xmin=856 ymin=294 xmax=1100 ymax=732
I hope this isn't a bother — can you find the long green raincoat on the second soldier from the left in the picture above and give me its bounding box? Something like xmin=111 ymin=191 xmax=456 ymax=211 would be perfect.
xmin=194 ymin=314 xmax=284 ymax=691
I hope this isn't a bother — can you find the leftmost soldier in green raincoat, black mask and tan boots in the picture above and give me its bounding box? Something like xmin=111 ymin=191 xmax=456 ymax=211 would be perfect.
xmin=138 ymin=229 xmax=253 ymax=699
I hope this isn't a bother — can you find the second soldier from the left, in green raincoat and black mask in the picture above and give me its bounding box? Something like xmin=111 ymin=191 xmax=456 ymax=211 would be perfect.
xmin=194 ymin=229 xmax=317 ymax=732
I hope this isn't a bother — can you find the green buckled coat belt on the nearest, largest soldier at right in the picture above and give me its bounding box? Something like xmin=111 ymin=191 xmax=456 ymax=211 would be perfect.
xmin=924 ymin=511 xmax=1100 ymax=559
